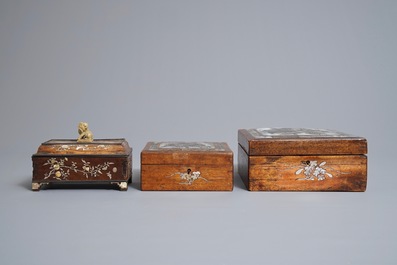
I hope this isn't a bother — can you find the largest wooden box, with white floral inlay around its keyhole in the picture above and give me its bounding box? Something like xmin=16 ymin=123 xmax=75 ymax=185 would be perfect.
xmin=238 ymin=128 xmax=367 ymax=191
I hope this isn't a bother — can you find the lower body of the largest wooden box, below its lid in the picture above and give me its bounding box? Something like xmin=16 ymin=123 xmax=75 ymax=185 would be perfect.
xmin=239 ymin=144 xmax=367 ymax=191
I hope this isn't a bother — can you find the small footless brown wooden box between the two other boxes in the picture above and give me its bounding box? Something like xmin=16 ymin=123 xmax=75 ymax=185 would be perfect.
xmin=141 ymin=142 xmax=233 ymax=191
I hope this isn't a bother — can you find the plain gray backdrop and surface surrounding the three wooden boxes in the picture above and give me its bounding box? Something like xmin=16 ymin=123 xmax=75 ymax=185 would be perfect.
xmin=0 ymin=0 xmax=397 ymax=264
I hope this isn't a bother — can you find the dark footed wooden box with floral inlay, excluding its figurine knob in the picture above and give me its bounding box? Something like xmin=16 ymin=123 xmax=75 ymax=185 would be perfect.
xmin=32 ymin=139 xmax=132 ymax=191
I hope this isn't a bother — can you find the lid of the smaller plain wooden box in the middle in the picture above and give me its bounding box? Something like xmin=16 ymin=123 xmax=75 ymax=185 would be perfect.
xmin=141 ymin=142 xmax=233 ymax=165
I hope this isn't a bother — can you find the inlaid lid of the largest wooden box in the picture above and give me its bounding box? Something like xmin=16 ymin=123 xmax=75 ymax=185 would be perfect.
xmin=238 ymin=128 xmax=367 ymax=156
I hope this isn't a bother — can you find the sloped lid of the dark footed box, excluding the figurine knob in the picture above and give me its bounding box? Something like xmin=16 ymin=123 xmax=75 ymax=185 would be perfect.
xmin=33 ymin=138 xmax=132 ymax=157
